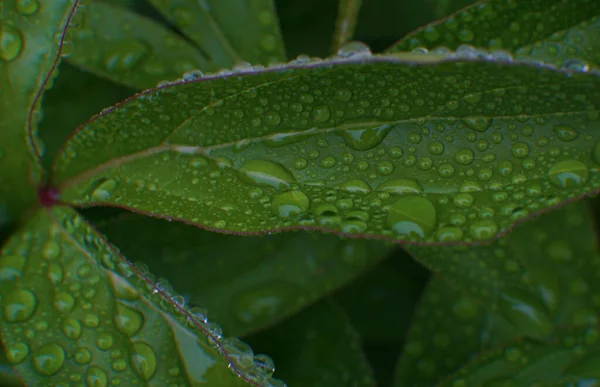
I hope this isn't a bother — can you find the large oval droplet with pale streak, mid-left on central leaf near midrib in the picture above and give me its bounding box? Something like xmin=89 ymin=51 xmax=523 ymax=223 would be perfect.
xmin=238 ymin=160 xmax=296 ymax=189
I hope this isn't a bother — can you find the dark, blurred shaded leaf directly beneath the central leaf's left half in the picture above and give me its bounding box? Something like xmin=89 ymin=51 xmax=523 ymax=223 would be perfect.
xmin=88 ymin=214 xmax=390 ymax=336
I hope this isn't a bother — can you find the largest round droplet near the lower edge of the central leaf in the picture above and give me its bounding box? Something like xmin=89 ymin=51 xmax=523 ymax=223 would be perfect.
xmin=387 ymin=196 xmax=437 ymax=238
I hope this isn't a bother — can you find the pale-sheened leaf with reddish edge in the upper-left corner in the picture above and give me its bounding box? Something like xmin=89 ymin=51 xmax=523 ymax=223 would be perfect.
xmin=0 ymin=0 xmax=75 ymax=224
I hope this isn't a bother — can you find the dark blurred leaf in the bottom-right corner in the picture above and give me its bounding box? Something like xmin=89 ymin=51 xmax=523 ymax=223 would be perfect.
xmin=439 ymin=327 xmax=600 ymax=387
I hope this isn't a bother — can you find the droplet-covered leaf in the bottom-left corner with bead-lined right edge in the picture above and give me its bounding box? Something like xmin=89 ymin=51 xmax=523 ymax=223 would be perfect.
xmin=0 ymin=207 xmax=286 ymax=386
